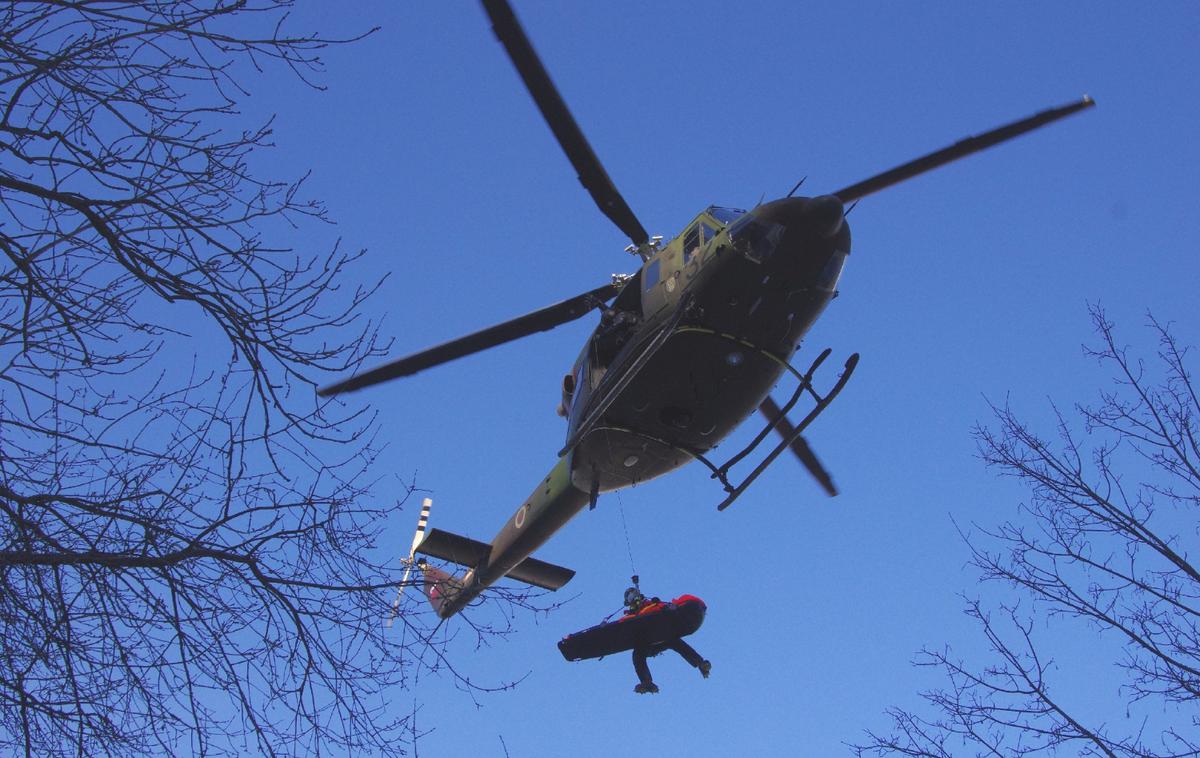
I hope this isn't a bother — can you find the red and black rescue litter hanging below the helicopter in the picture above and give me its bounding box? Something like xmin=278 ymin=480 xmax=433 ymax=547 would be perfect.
xmin=558 ymin=595 xmax=708 ymax=661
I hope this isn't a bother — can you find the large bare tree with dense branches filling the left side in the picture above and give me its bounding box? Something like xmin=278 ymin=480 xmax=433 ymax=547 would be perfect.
xmin=0 ymin=0 xmax=525 ymax=756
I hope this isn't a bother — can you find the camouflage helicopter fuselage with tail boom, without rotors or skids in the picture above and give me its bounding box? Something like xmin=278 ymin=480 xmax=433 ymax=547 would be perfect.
xmin=439 ymin=195 xmax=850 ymax=615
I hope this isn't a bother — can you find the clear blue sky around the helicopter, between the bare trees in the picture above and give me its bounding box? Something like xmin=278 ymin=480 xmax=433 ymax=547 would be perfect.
xmin=246 ymin=0 xmax=1200 ymax=757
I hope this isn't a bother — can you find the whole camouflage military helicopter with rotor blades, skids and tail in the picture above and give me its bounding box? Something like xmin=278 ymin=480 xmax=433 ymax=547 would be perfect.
xmin=320 ymin=0 xmax=1094 ymax=618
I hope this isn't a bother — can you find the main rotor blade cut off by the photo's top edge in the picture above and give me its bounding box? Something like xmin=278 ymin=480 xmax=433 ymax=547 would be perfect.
xmin=484 ymin=0 xmax=649 ymax=246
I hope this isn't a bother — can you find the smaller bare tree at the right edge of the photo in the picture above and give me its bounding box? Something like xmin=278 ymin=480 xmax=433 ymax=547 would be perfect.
xmin=854 ymin=307 xmax=1200 ymax=757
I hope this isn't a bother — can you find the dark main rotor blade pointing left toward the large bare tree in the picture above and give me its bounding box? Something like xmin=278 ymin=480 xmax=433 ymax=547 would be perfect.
xmin=317 ymin=279 xmax=620 ymax=397
